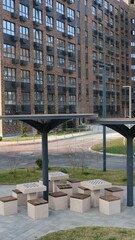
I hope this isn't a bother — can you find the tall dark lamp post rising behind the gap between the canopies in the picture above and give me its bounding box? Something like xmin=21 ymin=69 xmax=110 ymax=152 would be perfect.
xmin=97 ymin=62 xmax=111 ymax=171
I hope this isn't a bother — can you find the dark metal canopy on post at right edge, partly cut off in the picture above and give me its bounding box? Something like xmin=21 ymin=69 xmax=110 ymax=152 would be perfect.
xmin=94 ymin=118 xmax=135 ymax=207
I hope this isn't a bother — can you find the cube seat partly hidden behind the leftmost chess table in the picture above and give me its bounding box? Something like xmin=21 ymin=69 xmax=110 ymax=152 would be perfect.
xmin=12 ymin=189 xmax=27 ymax=206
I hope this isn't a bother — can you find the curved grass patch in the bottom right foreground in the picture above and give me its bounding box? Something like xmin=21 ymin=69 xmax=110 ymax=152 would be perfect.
xmin=39 ymin=227 xmax=135 ymax=240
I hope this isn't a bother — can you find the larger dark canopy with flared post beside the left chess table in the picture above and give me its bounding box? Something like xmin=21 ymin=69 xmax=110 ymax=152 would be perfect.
xmin=0 ymin=114 xmax=98 ymax=201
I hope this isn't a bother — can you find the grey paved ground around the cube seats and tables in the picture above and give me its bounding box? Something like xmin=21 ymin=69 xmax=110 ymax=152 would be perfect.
xmin=0 ymin=185 xmax=135 ymax=240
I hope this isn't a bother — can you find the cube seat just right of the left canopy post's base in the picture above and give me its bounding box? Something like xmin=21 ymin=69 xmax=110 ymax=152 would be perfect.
xmin=49 ymin=191 xmax=68 ymax=210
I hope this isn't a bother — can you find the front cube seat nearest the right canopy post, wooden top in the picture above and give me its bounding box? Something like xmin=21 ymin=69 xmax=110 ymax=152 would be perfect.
xmin=99 ymin=195 xmax=121 ymax=215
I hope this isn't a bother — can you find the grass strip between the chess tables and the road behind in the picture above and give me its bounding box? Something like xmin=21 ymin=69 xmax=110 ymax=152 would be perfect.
xmin=0 ymin=167 xmax=129 ymax=185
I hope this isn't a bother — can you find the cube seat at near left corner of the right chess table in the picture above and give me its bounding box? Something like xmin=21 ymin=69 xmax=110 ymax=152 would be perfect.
xmin=70 ymin=193 xmax=90 ymax=213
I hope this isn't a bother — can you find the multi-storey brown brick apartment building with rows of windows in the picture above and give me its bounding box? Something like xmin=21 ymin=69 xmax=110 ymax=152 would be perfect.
xmin=0 ymin=0 xmax=135 ymax=136
